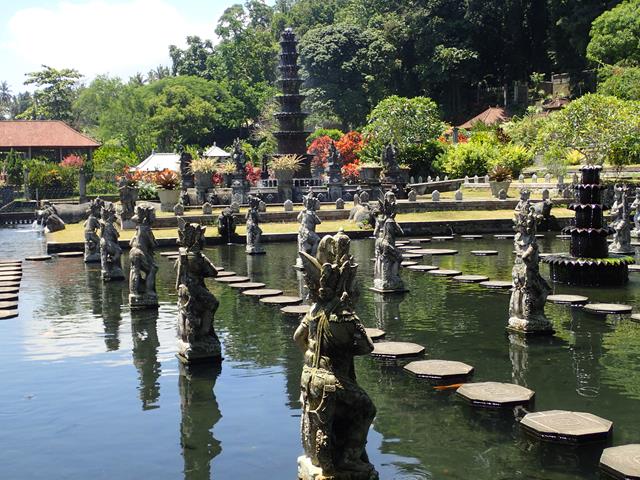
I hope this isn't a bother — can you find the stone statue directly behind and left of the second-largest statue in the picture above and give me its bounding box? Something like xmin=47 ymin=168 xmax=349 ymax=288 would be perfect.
xmin=129 ymin=205 xmax=158 ymax=309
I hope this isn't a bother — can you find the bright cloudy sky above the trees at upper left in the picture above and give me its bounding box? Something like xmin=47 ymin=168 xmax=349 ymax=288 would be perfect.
xmin=0 ymin=0 xmax=255 ymax=94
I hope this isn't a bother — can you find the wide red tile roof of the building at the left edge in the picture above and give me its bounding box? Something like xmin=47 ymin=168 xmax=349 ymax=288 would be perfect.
xmin=0 ymin=120 xmax=100 ymax=148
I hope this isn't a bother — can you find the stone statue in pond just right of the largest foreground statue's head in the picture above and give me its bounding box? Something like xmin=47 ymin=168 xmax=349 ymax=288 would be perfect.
xmin=373 ymin=192 xmax=406 ymax=292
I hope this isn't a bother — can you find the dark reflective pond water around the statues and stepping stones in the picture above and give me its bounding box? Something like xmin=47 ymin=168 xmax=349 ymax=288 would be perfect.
xmin=0 ymin=228 xmax=640 ymax=480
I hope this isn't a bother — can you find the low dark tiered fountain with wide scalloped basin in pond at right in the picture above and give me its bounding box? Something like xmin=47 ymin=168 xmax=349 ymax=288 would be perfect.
xmin=544 ymin=165 xmax=634 ymax=286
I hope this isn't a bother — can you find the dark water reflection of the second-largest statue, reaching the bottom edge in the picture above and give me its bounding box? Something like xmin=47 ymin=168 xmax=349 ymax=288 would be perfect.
xmin=178 ymin=364 xmax=222 ymax=480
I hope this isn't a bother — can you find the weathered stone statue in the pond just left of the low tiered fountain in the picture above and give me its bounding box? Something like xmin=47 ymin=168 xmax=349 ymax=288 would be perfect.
xmin=508 ymin=194 xmax=553 ymax=333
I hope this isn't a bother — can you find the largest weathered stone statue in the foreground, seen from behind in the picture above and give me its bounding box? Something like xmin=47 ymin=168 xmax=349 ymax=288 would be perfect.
xmin=293 ymin=234 xmax=378 ymax=480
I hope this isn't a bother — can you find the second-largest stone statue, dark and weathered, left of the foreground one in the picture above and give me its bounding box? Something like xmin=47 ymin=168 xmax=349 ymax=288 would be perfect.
xmin=176 ymin=217 xmax=222 ymax=363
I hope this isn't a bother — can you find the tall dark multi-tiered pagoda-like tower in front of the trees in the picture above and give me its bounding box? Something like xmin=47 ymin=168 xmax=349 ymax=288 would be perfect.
xmin=275 ymin=28 xmax=311 ymax=177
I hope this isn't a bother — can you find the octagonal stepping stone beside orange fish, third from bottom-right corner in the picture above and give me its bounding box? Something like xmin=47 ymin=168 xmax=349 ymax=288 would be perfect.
xmin=456 ymin=382 xmax=535 ymax=408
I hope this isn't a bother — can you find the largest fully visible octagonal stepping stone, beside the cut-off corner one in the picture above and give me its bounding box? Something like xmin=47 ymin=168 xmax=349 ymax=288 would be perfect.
xmin=520 ymin=410 xmax=613 ymax=443
